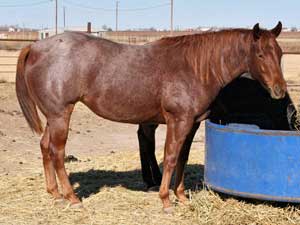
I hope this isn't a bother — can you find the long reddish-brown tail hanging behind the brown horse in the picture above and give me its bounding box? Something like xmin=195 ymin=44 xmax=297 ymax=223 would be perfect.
xmin=16 ymin=45 xmax=43 ymax=134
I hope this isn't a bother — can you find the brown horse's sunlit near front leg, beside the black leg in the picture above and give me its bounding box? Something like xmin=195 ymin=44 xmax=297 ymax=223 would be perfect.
xmin=159 ymin=112 xmax=194 ymax=213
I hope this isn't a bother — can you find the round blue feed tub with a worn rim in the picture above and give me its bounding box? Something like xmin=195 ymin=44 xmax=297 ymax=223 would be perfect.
xmin=204 ymin=120 xmax=300 ymax=203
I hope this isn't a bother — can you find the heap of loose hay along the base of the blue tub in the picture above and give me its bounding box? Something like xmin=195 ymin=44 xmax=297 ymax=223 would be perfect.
xmin=186 ymin=190 xmax=300 ymax=225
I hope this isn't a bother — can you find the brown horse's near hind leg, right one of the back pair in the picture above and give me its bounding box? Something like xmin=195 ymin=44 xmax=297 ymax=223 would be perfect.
xmin=48 ymin=105 xmax=80 ymax=204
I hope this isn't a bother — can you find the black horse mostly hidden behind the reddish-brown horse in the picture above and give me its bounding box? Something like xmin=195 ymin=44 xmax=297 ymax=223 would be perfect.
xmin=138 ymin=77 xmax=296 ymax=188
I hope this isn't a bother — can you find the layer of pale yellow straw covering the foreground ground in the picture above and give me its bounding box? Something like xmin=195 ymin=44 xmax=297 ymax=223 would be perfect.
xmin=0 ymin=149 xmax=300 ymax=225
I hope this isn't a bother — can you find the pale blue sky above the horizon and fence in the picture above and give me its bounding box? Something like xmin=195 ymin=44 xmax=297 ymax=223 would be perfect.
xmin=0 ymin=0 xmax=300 ymax=29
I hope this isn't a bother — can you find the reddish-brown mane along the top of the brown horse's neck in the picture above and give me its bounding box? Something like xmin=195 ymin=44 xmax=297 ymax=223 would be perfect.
xmin=154 ymin=29 xmax=252 ymax=82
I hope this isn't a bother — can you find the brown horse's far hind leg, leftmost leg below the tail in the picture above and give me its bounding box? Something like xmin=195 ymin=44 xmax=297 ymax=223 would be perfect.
xmin=40 ymin=124 xmax=62 ymax=199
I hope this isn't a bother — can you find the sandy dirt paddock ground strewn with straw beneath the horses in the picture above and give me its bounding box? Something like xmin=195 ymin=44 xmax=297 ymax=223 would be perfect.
xmin=0 ymin=83 xmax=300 ymax=225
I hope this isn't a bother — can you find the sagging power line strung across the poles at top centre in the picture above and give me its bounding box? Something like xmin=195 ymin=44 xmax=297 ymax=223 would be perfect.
xmin=64 ymin=0 xmax=170 ymax=12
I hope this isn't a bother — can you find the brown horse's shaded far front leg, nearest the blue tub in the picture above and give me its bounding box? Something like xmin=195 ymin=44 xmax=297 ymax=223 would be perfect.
xmin=174 ymin=123 xmax=200 ymax=203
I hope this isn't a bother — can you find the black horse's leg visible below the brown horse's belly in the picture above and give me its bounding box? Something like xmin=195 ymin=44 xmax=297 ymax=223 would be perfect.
xmin=138 ymin=124 xmax=162 ymax=188
